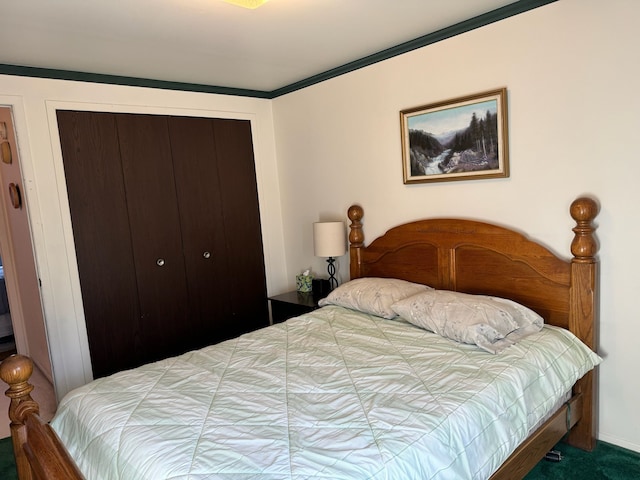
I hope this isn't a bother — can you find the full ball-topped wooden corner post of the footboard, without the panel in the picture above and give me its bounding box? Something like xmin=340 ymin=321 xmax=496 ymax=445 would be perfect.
xmin=0 ymin=355 xmax=40 ymax=480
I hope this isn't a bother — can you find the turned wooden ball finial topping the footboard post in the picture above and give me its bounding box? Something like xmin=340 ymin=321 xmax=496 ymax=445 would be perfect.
xmin=0 ymin=355 xmax=40 ymax=425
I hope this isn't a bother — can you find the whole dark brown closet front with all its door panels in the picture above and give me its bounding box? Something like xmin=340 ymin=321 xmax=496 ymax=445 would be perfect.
xmin=57 ymin=110 xmax=269 ymax=377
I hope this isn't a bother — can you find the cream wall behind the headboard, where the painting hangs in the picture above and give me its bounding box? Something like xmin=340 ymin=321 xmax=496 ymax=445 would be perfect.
xmin=273 ymin=0 xmax=640 ymax=451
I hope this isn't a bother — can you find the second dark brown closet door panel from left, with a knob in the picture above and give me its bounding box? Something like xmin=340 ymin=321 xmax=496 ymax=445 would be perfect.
xmin=116 ymin=114 xmax=190 ymax=362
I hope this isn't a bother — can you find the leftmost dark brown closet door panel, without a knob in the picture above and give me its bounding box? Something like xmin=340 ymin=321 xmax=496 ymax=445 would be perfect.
xmin=58 ymin=111 xmax=144 ymax=376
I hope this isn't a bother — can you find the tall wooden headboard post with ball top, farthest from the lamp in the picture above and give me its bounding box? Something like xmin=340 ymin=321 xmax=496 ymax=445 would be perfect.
xmin=568 ymin=197 xmax=598 ymax=451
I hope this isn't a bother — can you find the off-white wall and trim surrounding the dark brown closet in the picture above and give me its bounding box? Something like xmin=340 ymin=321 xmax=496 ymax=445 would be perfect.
xmin=0 ymin=75 xmax=286 ymax=397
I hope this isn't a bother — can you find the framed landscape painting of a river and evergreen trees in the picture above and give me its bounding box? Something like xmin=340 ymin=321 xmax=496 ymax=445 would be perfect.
xmin=400 ymin=88 xmax=509 ymax=184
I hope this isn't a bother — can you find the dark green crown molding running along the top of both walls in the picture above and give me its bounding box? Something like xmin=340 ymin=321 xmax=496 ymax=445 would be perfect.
xmin=0 ymin=0 xmax=558 ymax=99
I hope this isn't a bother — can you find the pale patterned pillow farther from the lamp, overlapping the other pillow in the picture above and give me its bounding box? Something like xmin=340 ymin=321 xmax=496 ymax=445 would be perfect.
xmin=391 ymin=290 xmax=544 ymax=353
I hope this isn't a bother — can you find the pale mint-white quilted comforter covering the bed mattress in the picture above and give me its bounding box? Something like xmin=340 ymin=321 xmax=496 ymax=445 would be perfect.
xmin=51 ymin=306 xmax=600 ymax=480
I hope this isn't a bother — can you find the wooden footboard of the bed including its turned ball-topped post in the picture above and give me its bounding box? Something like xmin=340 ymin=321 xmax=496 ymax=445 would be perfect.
xmin=0 ymin=355 xmax=84 ymax=480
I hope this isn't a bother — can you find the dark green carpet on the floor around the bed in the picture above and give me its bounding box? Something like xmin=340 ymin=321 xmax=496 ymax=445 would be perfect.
xmin=0 ymin=438 xmax=640 ymax=480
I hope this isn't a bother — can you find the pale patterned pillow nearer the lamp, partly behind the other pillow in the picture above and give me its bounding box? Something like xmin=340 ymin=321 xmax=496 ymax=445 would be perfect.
xmin=318 ymin=277 xmax=432 ymax=319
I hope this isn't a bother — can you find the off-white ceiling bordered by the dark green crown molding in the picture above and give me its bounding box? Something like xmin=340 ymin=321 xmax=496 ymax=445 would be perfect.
xmin=0 ymin=0 xmax=549 ymax=97
